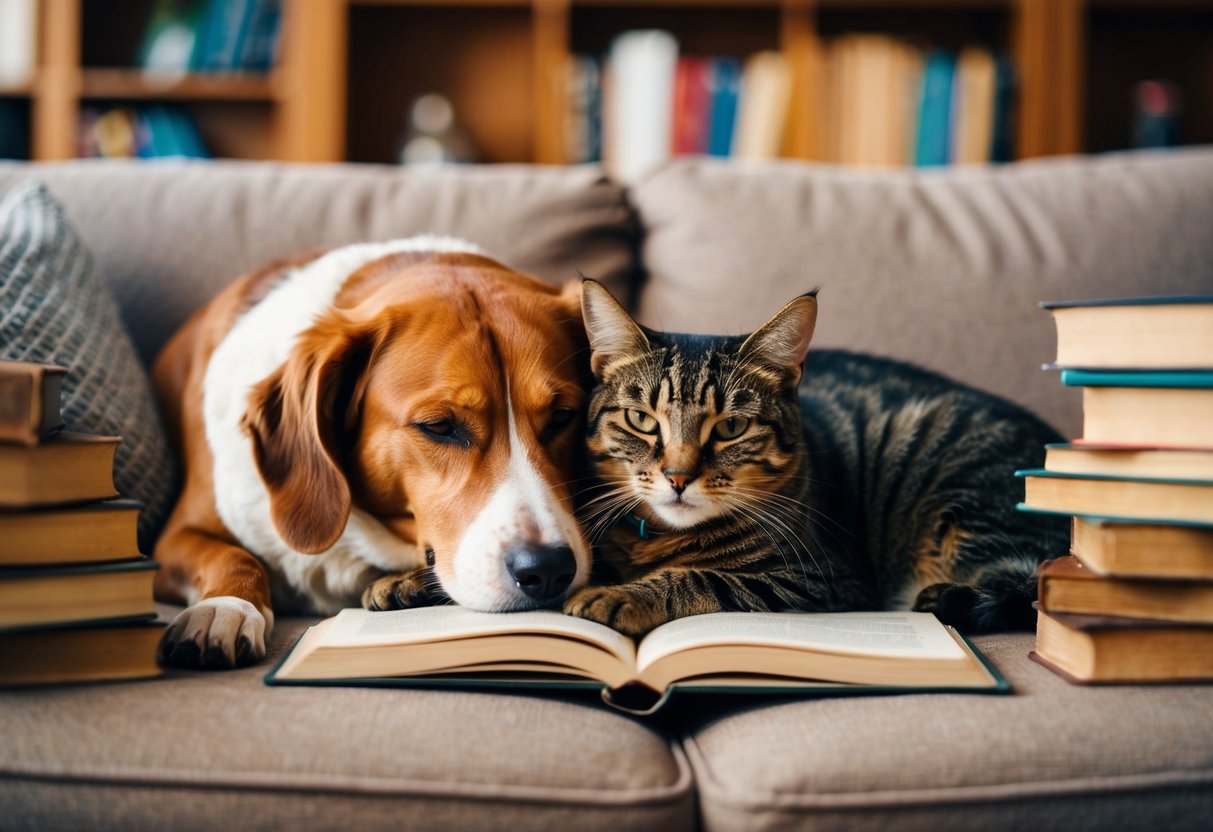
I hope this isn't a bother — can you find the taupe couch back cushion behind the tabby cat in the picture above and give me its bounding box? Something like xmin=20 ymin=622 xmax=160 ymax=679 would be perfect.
xmin=632 ymin=149 xmax=1213 ymax=434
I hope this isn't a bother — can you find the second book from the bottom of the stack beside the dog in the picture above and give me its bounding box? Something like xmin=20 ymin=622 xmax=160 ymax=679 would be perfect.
xmin=0 ymin=558 xmax=156 ymax=628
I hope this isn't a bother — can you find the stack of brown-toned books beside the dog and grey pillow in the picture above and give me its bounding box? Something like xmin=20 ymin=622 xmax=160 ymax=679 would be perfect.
xmin=0 ymin=361 xmax=163 ymax=685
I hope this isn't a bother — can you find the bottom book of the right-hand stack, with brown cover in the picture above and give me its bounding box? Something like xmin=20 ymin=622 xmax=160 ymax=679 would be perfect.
xmin=1029 ymin=611 xmax=1213 ymax=684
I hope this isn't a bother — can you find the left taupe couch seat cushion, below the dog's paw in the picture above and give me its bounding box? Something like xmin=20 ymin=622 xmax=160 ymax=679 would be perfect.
xmin=0 ymin=619 xmax=694 ymax=831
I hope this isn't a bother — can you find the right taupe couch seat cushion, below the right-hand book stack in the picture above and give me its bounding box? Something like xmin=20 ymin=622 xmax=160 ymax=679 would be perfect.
xmin=684 ymin=633 xmax=1213 ymax=831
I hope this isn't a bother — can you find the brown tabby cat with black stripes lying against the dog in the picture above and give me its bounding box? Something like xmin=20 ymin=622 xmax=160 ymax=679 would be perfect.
xmin=564 ymin=280 xmax=1069 ymax=637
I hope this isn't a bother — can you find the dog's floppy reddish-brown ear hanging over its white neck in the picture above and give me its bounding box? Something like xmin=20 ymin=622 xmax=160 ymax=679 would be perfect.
xmin=243 ymin=318 xmax=376 ymax=554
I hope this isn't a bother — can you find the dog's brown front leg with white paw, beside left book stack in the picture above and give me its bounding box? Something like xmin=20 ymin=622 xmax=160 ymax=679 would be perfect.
xmin=155 ymin=520 xmax=274 ymax=669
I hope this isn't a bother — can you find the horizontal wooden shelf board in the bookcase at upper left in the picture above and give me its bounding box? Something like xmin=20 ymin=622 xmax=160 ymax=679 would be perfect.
xmin=80 ymin=69 xmax=279 ymax=102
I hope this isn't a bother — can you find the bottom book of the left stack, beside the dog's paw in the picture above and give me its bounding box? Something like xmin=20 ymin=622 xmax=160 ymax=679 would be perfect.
xmin=0 ymin=616 xmax=165 ymax=686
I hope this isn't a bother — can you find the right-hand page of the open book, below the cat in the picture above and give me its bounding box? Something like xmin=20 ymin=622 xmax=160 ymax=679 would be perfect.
xmin=637 ymin=612 xmax=964 ymax=671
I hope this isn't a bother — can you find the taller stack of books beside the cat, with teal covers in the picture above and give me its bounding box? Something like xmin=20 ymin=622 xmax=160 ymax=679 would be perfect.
xmin=1020 ymin=296 xmax=1213 ymax=683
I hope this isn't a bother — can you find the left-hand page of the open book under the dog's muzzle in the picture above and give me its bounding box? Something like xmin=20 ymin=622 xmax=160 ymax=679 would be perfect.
xmin=324 ymin=605 xmax=636 ymax=666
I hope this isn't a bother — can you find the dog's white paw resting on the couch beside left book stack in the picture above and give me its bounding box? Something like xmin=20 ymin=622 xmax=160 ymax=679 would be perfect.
xmin=158 ymin=595 xmax=274 ymax=669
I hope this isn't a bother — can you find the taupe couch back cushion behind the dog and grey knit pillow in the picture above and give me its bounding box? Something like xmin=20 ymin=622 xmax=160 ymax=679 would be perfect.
xmin=0 ymin=160 xmax=633 ymax=361
